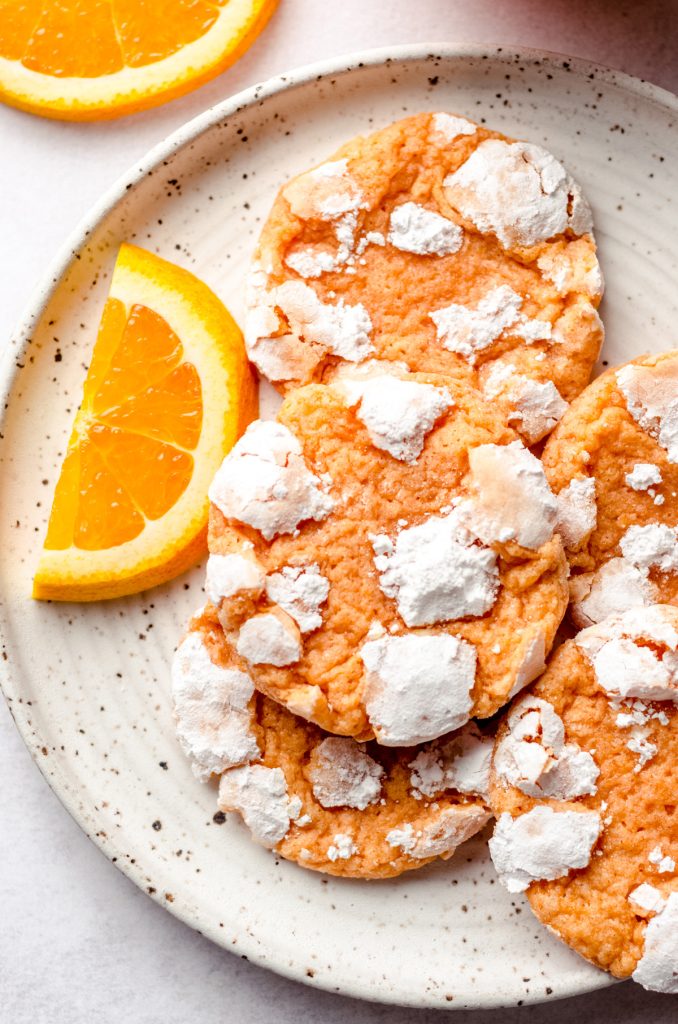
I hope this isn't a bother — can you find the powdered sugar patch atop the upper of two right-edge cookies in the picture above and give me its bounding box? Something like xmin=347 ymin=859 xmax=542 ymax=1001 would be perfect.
xmin=617 ymin=358 xmax=678 ymax=463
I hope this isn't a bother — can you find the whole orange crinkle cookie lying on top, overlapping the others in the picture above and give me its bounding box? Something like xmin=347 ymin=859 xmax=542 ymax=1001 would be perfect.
xmin=206 ymin=362 xmax=567 ymax=746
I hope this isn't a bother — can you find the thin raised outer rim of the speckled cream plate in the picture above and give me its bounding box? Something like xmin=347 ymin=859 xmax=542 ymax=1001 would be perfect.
xmin=0 ymin=42 xmax=678 ymax=1010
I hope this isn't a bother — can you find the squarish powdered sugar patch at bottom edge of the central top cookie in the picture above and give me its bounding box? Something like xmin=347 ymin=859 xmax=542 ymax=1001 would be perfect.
xmin=361 ymin=634 xmax=476 ymax=746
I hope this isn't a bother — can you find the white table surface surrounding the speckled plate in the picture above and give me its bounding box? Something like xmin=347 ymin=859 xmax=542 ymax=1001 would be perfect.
xmin=0 ymin=0 xmax=678 ymax=1024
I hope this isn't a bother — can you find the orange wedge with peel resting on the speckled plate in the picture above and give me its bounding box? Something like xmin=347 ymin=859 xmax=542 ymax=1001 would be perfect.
xmin=33 ymin=245 xmax=257 ymax=601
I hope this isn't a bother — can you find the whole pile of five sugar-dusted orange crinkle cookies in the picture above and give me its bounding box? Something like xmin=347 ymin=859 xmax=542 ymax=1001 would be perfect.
xmin=173 ymin=114 xmax=678 ymax=991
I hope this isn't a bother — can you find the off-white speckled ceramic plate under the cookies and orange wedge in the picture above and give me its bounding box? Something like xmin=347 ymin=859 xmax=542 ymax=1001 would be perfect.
xmin=0 ymin=47 xmax=678 ymax=1008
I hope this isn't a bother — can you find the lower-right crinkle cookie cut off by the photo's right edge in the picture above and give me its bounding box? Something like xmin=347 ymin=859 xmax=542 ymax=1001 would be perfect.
xmin=490 ymin=605 xmax=678 ymax=992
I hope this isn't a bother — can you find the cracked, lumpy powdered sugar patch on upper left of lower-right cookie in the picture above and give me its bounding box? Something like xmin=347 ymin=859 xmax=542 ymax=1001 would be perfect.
xmin=494 ymin=694 xmax=600 ymax=800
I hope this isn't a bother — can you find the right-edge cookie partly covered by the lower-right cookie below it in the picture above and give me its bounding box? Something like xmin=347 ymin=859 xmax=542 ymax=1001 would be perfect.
xmin=543 ymin=351 xmax=678 ymax=627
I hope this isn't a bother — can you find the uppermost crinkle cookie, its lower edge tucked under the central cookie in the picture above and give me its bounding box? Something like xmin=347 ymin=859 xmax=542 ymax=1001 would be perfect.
xmin=245 ymin=114 xmax=603 ymax=444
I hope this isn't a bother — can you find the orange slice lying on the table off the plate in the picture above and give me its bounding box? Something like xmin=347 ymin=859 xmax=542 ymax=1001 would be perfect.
xmin=0 ymin=0 xmax=278 ymax=121
